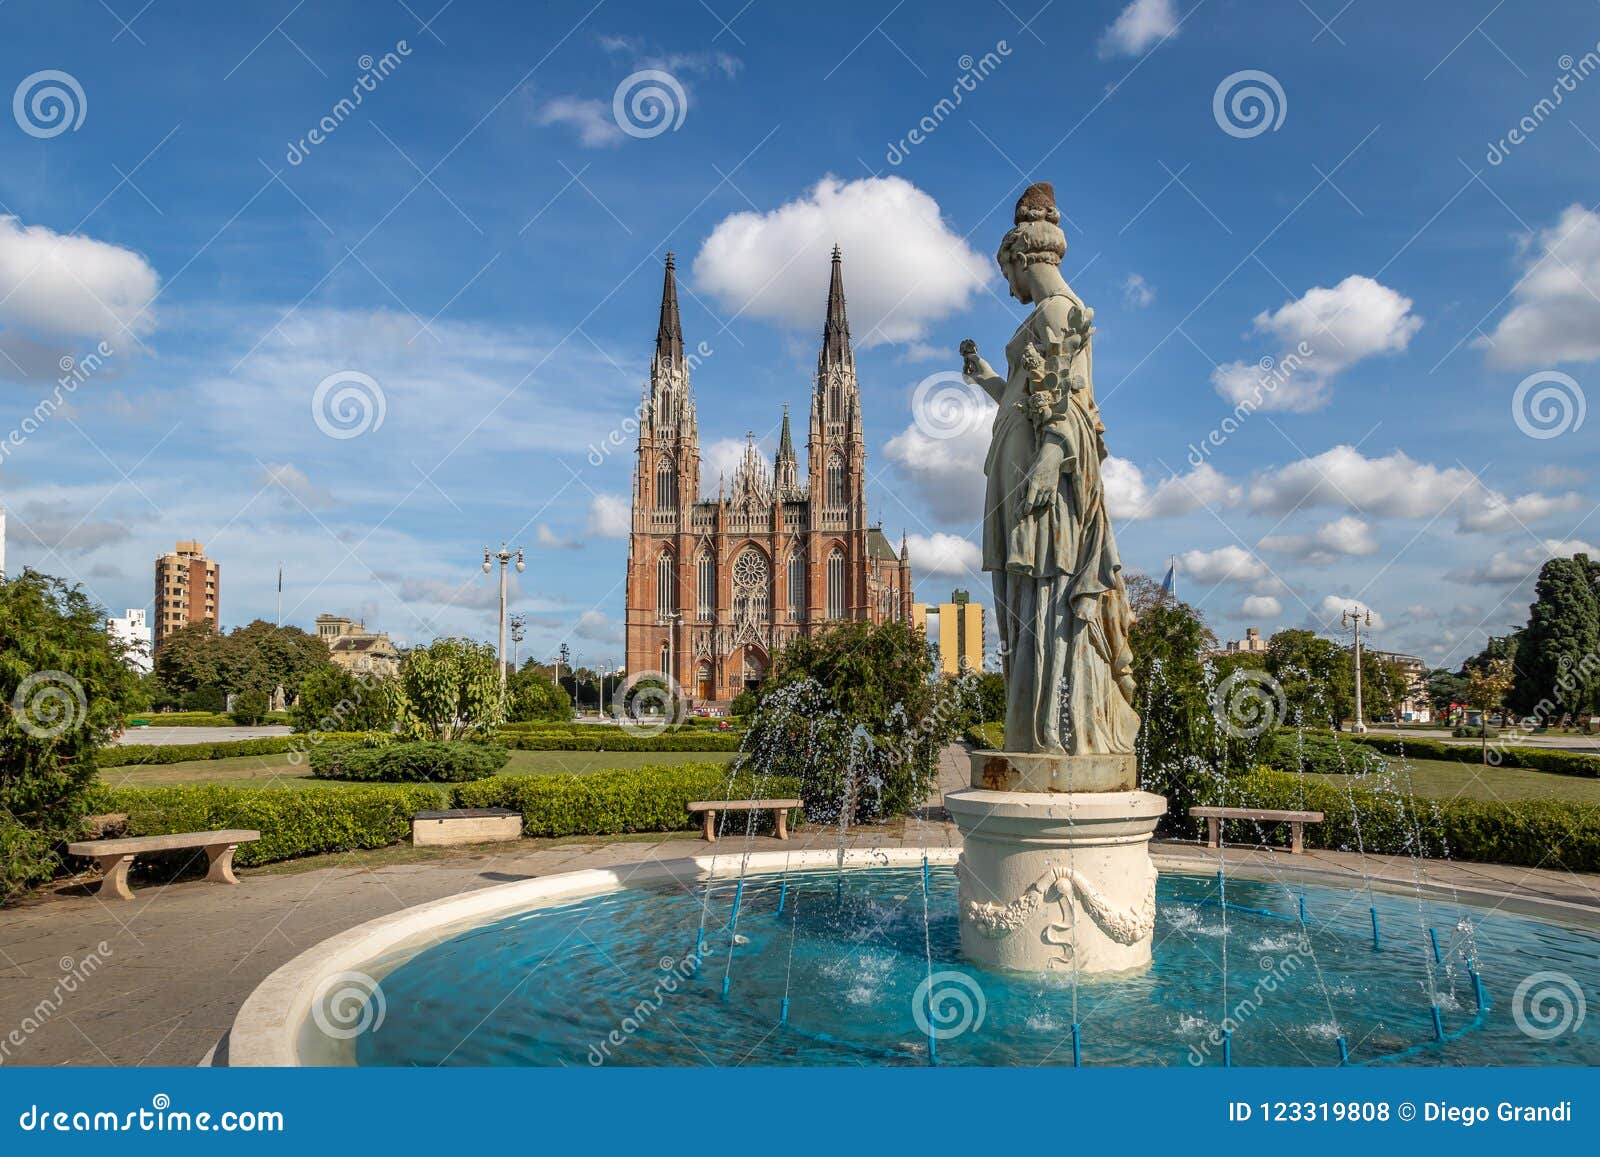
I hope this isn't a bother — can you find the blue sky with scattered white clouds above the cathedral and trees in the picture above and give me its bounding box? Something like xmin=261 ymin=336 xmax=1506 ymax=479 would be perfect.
xmin=0 ymin=0 xmax=1600 ymax=664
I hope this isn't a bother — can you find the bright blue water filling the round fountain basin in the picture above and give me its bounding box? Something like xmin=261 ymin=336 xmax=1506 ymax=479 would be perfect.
xmin=344 ymin=867 xmax=1600 ymax=1066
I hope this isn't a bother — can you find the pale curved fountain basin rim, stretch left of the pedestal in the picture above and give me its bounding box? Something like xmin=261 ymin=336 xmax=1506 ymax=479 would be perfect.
xmin=227 ymin=847 xmax=960 ymax=1067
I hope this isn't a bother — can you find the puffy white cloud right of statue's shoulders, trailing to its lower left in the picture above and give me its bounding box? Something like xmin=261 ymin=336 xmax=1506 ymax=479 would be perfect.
xmin=1211 ymin=274 xmax=1422 ymax=413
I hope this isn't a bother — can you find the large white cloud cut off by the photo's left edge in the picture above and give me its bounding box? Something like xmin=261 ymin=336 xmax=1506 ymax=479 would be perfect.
xmin=0 ymin=214 xmax=160 ymax=381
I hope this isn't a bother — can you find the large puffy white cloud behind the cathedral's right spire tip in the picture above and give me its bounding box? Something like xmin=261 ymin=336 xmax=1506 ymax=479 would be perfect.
xmin=694 ymin=176 xmax=994 ymax=347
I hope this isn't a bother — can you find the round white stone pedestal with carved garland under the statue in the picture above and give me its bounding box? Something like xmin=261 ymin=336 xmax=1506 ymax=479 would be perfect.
xmin=944 ymin=787 xmax=1166 ymax=975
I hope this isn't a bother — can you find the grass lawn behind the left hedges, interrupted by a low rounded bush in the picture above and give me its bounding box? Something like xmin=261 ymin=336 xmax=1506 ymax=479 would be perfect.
xmin=101 ymin=751 xmax=734 ymax=787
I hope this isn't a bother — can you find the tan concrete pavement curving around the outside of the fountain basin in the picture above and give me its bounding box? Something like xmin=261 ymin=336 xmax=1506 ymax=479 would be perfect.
xmin=0 ymin=747 xmax=1600 ymax=1066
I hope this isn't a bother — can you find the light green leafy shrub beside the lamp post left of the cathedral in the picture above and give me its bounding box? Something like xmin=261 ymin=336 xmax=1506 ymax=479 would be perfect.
xmin=400 ymin=639 xmax=504 ymax=739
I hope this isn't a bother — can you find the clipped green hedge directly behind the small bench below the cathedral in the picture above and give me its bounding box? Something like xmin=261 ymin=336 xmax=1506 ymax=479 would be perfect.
xmin=456 ymin=763 xmax=800 ymax=835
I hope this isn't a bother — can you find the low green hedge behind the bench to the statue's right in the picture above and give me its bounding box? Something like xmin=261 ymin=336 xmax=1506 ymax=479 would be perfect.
xmin=1192 ymin=768 xmax=1600 ymax=872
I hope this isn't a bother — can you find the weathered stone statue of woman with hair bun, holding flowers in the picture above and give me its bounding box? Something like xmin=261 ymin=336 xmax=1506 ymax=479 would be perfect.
xmin=962 ymin=184 xmax=1139 ymax=755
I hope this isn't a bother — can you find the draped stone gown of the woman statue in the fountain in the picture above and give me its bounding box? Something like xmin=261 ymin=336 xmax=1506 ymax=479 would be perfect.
xmin=984 ymin=290 xmax=1139 ymax=755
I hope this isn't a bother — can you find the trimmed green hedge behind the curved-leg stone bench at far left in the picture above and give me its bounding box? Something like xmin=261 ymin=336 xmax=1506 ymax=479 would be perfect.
xmin=94 ymin=784 xmax=450 ymax=867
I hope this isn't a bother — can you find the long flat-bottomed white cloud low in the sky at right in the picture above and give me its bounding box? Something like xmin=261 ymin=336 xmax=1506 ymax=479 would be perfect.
xmin=1245 ymin=446 xmax=1582 ymax=531
